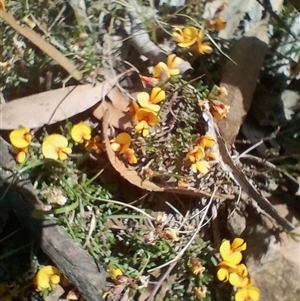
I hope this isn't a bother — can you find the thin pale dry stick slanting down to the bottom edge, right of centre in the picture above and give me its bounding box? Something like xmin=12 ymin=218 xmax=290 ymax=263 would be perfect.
xmin=147 ymin=187 xmax=217 ymax=301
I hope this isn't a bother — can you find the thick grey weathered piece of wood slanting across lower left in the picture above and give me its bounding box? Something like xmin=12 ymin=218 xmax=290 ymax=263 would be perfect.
xmin=0 ymin=138 xmax=109 ymax=301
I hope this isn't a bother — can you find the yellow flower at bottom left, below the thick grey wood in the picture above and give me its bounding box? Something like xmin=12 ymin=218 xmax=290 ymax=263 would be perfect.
xmin=34 ymin=265 xmax=60 ymax=291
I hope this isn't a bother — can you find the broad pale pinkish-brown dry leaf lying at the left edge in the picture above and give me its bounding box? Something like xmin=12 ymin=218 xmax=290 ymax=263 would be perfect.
xmin=0 ymin=82 xmax=112 ymax=130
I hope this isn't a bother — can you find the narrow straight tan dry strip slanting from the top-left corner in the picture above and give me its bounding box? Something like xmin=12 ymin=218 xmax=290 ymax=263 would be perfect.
xmin=0 ymin=10 xmax=82 ymax=81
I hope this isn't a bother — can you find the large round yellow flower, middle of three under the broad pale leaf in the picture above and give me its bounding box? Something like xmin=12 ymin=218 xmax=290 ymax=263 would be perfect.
xmin=42 ymin=134 xmax=72 ymax=161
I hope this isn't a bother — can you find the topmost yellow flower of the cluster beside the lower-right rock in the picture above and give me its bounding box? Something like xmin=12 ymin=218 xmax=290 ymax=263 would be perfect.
xmin=220 ymin=238 xmax=247 ymax=264
